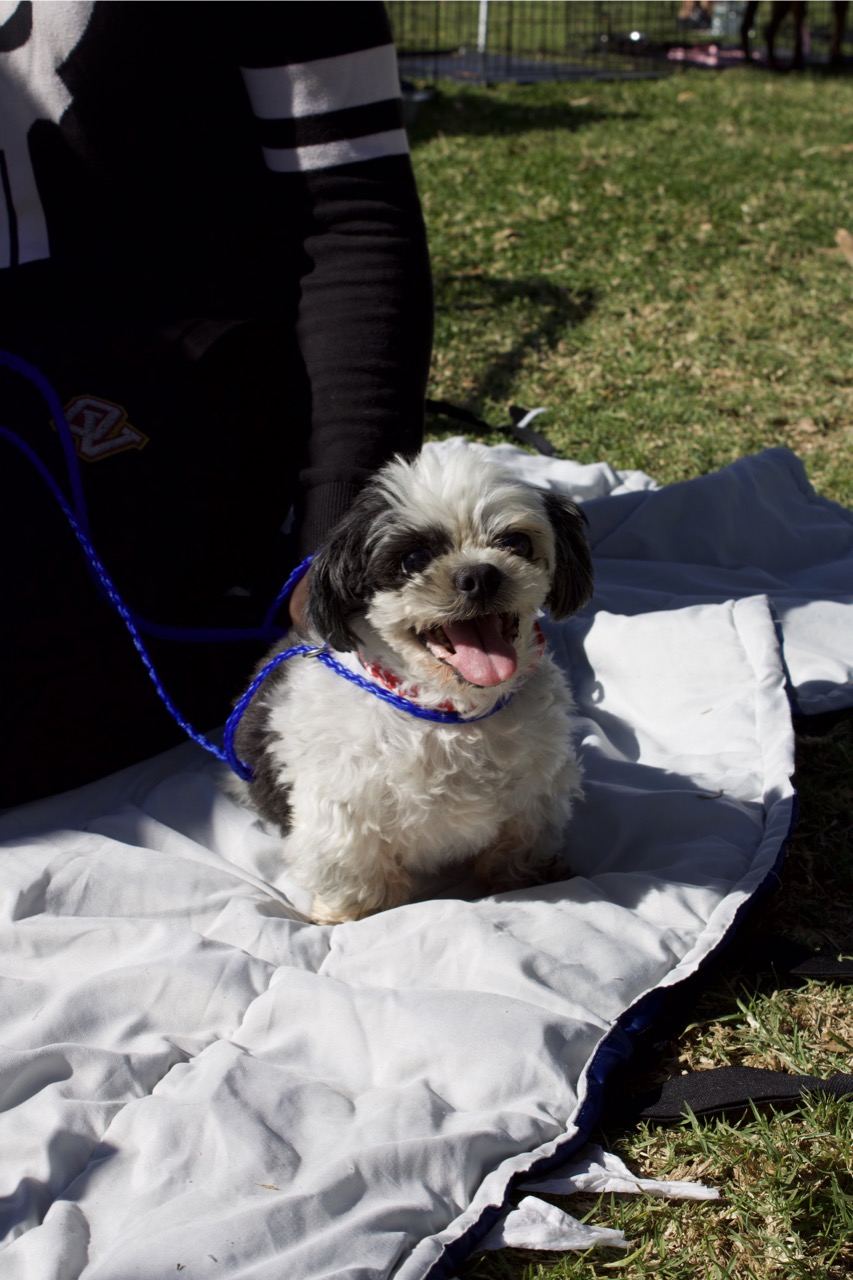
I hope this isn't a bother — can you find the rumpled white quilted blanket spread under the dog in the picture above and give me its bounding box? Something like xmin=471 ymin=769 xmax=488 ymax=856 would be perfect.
xmin=0 ymin=447 xmax=853 ymax=1280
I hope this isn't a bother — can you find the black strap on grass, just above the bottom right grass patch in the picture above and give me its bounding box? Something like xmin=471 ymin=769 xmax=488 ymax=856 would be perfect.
xmin=634 ymin=1066 xmax=853 ymax=1123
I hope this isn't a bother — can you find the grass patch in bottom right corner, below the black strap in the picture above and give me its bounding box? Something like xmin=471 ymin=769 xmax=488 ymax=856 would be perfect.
xmin=460 ymin=1100 xmax=853 ymax=1280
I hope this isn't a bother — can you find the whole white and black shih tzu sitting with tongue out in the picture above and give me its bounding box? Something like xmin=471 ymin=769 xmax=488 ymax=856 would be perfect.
xmin=230 ymin=442 xmax=592 ymax=923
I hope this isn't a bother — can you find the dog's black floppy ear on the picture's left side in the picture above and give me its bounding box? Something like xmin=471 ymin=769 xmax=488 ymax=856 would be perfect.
xmin=306 ymin=486 xmax=387 ymax=653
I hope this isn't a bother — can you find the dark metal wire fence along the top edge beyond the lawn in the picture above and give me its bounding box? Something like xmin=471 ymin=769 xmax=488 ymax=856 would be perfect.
xmin=387 ymin=0 xmax=845 ymax=83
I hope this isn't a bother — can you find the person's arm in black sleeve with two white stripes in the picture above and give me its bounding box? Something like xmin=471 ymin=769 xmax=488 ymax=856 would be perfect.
xmin=229 ymin=3 xmax=432 ymax=554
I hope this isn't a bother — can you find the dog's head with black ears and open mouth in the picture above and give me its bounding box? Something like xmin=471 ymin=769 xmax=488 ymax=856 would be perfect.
xmin=309 ymin=444 xmax=592 ymax=696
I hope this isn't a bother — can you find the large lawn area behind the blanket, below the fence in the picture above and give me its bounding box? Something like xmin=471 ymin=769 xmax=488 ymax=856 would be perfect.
xmin=404 ymin=72 xmax=853 ymax=504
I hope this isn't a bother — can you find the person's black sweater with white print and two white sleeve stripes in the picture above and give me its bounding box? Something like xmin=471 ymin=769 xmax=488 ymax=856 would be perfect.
xmin=0 ymin=0 xmax=432 ymax=550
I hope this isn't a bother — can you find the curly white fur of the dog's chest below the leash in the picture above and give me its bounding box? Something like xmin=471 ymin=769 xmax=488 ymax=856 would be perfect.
xmin=258 ymin=658 xmax=580 ymax=918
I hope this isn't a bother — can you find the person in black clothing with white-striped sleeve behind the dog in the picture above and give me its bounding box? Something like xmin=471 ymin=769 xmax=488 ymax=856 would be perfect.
xmin=0 ymin=0 xmax=432 ymax=806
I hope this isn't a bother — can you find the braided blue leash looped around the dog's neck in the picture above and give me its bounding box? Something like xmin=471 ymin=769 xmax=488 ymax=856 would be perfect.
xmin=0 ymin=351 xmax=512 ymax=782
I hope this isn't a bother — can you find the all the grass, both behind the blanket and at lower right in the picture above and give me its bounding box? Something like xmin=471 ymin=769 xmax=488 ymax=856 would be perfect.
xmin=411 ymin=69 xmax=853 ymax=1280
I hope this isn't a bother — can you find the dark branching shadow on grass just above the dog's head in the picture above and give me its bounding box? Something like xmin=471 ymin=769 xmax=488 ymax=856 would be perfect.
xmin=435 ymin=275 xmax=597 ymax=402
